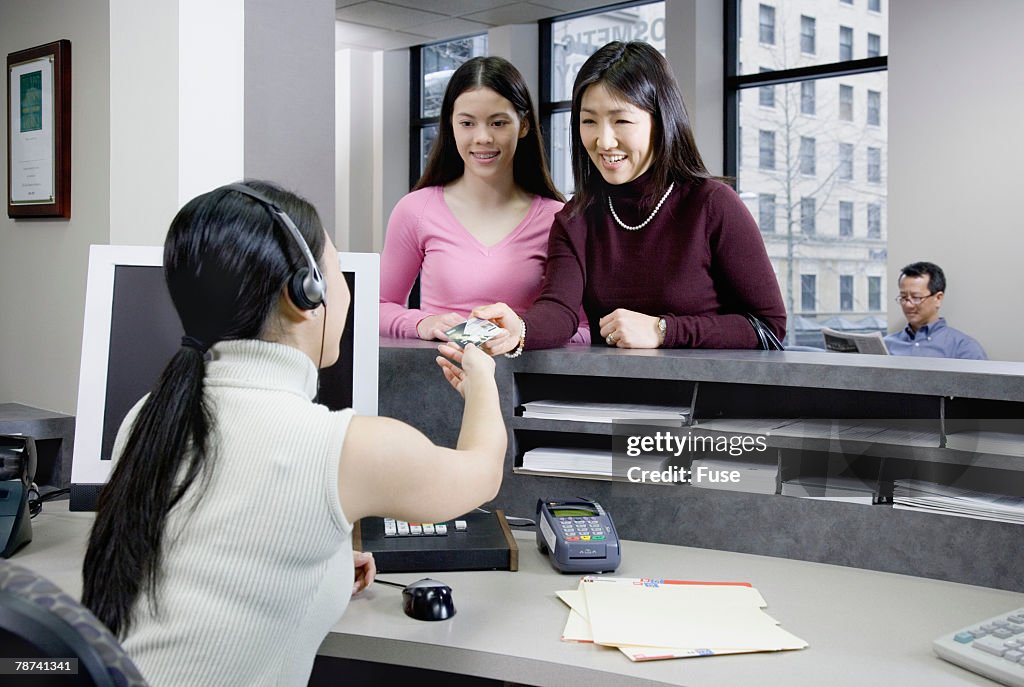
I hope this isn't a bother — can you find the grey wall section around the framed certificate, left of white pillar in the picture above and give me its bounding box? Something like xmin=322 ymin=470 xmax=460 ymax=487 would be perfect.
xmin=0 ymin=0 xmax=111 ymax=414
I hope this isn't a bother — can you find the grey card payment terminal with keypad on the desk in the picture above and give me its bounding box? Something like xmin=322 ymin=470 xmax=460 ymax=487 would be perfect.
xmin=537 ymin=499 xmax=622 ymax=572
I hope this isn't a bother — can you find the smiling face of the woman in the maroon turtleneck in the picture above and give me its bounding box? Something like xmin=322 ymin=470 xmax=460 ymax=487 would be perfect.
xmin=580 ymin=83 xmax=654 ymax=184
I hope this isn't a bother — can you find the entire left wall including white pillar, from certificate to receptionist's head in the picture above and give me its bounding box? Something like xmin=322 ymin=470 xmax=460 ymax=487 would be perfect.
xmin=0 ymin=0 xmax=335 ymax=414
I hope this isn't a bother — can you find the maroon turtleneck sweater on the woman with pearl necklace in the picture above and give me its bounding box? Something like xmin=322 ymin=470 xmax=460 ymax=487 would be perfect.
xmin=522 ymin=172 xmax=785 ymax=348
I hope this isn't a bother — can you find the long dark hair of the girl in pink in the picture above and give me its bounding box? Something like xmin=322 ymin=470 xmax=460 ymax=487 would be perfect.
xmin=416 ymin=57 xmax=565 ymax=201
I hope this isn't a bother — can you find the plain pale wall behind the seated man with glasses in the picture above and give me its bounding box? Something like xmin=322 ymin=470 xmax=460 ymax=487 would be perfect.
xmin=887 ymin=0 xmax=1024 ymax=360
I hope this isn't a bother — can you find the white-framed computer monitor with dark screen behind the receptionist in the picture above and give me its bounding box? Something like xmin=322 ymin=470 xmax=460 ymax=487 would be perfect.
xmin=71 ymin=246 xmax=380 ymax=511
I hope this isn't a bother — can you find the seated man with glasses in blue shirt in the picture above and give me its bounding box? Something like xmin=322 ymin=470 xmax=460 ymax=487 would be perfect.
xmin=886 ymin=262 xmax=988 ymax=360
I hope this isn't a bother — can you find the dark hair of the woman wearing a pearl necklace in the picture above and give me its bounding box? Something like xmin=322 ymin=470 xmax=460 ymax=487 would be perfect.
xmin=571 ymin=41 xmax=712 ymax=214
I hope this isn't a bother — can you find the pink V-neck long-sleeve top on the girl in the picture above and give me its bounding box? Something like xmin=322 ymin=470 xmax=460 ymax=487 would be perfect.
xmin=380 ymin=186 xmax=590 ymax=343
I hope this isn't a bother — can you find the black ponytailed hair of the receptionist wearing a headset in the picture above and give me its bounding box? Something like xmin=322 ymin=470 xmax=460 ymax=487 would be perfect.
xmin=82 ymin=181 xmax=325 ymax=637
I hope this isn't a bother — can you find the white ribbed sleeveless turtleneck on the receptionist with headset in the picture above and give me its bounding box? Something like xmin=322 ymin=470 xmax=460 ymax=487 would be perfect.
xmin=115 ymin=340 xmax=353 ymax=687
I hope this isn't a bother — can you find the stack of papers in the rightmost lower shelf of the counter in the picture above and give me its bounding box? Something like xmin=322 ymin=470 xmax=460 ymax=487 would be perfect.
xmin=893 ymin=479 xmax=1024 ymax=524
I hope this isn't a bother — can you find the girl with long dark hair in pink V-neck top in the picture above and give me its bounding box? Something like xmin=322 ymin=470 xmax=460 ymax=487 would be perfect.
xmin=380 ymin=57 xmax=590 ymax=343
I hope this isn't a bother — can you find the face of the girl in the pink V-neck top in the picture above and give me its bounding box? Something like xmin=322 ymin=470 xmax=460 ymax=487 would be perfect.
xmin=452 ymin=87 xmax=527 ymax=177
